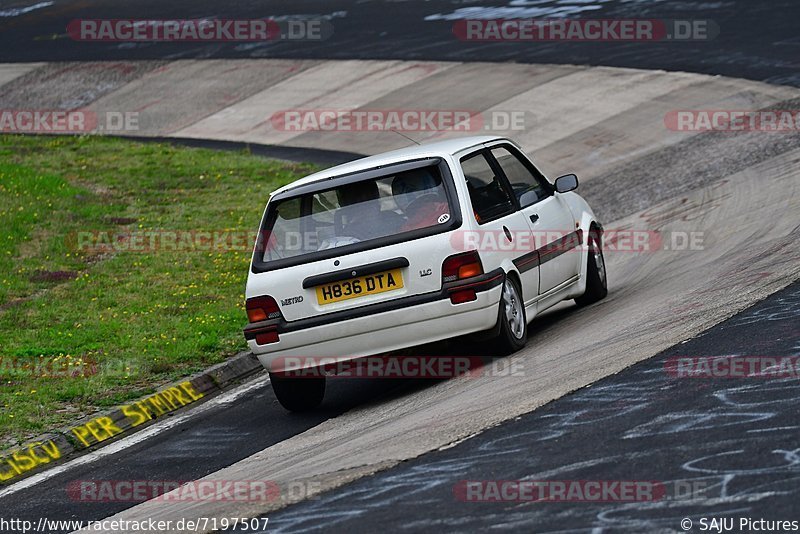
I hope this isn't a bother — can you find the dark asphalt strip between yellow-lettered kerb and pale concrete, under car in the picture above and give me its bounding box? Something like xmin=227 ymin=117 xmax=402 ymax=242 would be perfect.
xmin=2 ymin=368 xmax=476 ymax=532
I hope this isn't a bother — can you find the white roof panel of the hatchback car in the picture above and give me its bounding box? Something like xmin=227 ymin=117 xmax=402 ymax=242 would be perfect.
xmin=270 ymin=135 xmax=505 ymax=196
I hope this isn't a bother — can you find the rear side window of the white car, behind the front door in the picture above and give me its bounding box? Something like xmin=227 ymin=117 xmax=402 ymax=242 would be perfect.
xmin=461 ymin=152 xmax=514 ymax=224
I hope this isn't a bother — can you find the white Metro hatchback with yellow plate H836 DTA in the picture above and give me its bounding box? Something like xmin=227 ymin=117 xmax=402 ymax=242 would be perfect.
xmin=244 ymin=136 xmax=607 ymax=411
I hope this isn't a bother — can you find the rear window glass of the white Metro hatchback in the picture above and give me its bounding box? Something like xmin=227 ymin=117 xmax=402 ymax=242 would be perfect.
xmin=254 ymin=160 xmax=460 ymax=268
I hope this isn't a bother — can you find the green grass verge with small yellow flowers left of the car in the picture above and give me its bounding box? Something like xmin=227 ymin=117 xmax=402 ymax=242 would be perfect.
xmin=0 ymin=135 xmax=316 ymax=448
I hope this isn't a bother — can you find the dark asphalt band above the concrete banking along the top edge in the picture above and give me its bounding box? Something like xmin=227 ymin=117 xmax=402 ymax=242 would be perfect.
xmin=0 ymin=0 xmax=800 ymax=86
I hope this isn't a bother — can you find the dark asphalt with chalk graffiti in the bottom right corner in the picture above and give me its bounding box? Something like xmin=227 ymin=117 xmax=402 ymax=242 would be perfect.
xmin=269 ymin=283 xmax=800 ymax=532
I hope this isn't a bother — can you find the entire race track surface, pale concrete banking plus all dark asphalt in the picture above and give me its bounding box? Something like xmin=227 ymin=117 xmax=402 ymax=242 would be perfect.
xmin=0 ymin=0 xmax=800 ymax=532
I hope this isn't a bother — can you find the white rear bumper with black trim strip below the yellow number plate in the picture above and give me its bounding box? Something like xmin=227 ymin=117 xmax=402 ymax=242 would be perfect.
xmin=245 ymin=269 xmax=505 ymax=370
